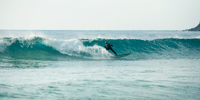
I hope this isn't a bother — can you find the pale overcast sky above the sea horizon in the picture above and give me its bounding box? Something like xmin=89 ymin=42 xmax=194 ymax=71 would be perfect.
xmin=0 ymin=0 xmax=200 ymax=30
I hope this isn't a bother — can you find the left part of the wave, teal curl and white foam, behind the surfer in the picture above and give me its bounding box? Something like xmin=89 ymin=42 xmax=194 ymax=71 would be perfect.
xmin=0 ymin=37 xmax=111 ymax=60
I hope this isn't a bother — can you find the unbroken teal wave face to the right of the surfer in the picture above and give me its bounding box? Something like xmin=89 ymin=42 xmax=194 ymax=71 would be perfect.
xmin=83 ymin=38 xmax=200 ymax=59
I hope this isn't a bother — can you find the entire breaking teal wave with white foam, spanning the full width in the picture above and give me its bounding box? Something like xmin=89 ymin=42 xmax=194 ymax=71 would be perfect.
xmin=0 ymin=37 xmax=200 ymax=60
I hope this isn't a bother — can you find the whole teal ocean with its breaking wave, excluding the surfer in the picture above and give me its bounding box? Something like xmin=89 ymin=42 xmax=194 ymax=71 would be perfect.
xmin=0 ymin=30 xmax=200 ymax=100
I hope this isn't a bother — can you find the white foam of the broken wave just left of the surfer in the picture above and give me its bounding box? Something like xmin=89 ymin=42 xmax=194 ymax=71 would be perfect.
xmin=45 ymin=39 xmax=110 ymax=58
